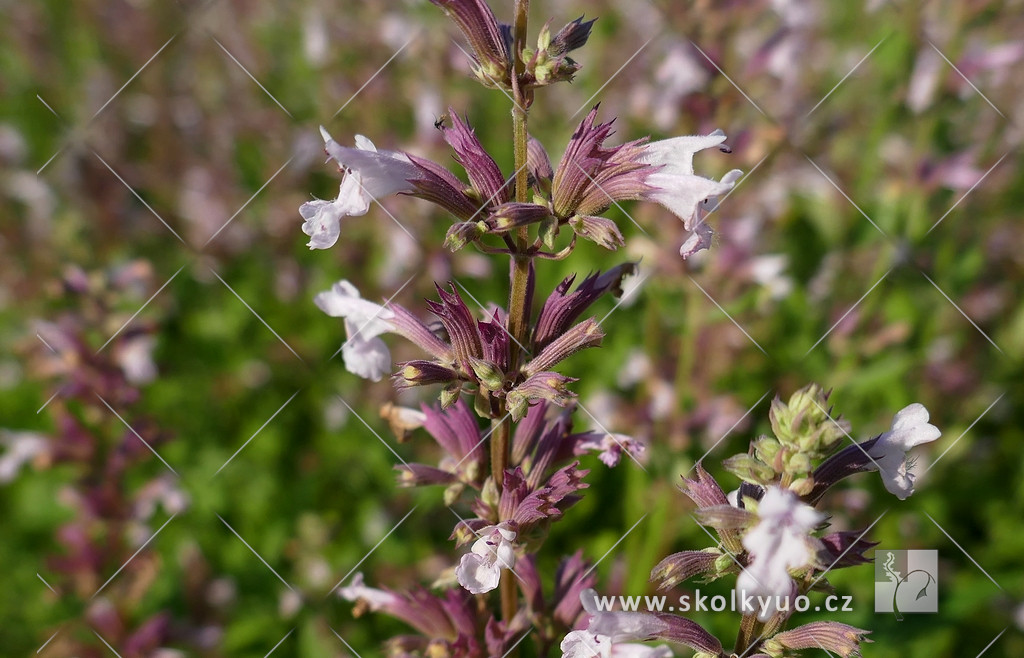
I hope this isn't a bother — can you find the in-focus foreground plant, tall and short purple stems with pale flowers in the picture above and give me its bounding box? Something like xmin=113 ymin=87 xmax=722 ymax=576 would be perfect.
xmin=299 ymin=0 xmax=938 ymax=658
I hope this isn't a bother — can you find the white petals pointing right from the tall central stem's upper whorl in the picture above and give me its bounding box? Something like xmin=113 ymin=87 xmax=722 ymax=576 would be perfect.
xmin=640 ymin=130 xmax=742 ymax=258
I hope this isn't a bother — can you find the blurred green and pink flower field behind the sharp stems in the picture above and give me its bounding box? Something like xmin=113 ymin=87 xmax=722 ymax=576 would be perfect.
xmin=0 ymin=0 xmax=1024 ymax=658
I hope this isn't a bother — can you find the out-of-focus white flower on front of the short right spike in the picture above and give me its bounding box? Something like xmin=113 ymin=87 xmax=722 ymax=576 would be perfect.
xmin=736 ymin=486 xmax=824 ymax=621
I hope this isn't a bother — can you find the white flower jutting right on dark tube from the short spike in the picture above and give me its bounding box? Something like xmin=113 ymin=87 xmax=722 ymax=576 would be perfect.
xmin=867 ymin=402 xmax=942 ymax=500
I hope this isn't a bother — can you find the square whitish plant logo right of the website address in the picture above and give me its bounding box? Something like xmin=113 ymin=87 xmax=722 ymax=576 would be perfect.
xmin=874 ymin=549 xmax=939 ymax=621
